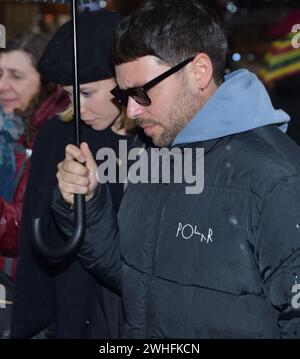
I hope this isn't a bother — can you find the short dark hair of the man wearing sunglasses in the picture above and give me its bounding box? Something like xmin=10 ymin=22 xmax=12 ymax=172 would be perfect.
xmin=112 ymin=0 xmax=227 ymax=84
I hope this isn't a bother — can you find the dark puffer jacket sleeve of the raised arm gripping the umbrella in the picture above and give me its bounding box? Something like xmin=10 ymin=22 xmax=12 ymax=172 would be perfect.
xmin=52 ymin=185 xmax=121 ymax=294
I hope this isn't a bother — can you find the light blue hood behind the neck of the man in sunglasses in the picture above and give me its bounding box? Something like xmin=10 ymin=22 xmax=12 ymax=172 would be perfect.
xmin=173 ymin=70 xmax=290 ymax=146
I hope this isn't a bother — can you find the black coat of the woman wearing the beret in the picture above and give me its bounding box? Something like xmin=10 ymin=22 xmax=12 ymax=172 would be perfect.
xmin=11 ymin=118 xmax=144 ymax=338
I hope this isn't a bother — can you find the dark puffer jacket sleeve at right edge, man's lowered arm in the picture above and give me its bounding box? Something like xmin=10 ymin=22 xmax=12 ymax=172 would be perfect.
xmin=256 ymin=176 xmax=300 ymax=338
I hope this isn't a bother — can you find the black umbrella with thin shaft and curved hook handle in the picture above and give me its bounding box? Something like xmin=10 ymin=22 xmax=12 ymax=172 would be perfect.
xmin=12 ymin=0 xmax=100 ymax=259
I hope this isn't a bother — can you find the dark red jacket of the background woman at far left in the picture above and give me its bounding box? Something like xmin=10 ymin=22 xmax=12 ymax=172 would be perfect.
xmin=0 ymin=88 xmax=69 ymax=277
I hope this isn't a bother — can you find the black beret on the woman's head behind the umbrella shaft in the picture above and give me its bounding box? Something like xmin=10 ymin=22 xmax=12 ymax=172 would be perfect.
xmin=38 ymin=10 xmax=122 ymax=86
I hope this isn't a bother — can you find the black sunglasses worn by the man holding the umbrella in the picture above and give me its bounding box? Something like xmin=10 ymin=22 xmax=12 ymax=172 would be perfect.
xmin=110 ymin=57 xmax=194 ymax=107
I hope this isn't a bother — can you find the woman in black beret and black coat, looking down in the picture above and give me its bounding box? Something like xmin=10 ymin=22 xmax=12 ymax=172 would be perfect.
xmin=12 ymin=11 xmax=149 ymax=338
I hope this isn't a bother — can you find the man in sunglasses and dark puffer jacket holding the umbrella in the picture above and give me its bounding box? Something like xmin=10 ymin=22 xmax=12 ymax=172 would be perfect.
xmin=53 ymin=0 xmax=300 ymax=338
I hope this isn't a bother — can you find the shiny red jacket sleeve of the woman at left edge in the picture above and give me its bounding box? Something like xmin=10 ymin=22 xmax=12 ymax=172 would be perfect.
xmin=0 ymin=162 xmax=29 ymax=257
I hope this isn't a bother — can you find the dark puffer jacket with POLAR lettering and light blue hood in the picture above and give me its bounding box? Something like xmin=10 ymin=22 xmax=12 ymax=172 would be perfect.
xmin=53 ymin=72 xmax=300 ymax=338
